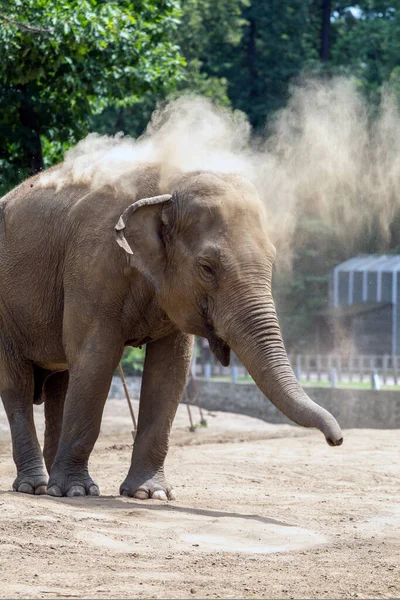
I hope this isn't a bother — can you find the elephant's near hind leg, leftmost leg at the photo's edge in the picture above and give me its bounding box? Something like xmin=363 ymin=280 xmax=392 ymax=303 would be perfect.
xmin=0 ymin=346 xmax=47 ymax=494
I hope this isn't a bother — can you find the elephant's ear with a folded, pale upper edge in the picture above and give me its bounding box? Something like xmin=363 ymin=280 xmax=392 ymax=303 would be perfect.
xmin=115 ymin=194 xmax=172 ymax=291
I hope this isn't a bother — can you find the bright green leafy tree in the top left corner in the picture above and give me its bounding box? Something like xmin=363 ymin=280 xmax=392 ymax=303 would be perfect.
xmin=0 ymin=0 xmax=184 ymax=192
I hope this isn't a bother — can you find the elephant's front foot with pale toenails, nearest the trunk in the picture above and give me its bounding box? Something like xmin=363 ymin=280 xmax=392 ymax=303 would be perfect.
xmin=119 ymin=472 xmax=176 ymax=500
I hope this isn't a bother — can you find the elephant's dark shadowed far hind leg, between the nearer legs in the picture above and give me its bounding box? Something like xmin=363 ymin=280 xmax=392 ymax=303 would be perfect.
xmin=43 ymin=371 xmax=68 ymax=473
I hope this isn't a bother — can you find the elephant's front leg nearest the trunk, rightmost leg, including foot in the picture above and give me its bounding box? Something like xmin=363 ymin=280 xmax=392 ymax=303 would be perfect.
xmin=120 ymin=332 xmax=193 ymax=500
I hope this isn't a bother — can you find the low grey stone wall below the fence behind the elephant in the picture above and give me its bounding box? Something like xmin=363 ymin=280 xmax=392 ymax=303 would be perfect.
xmin=110 ymin=377 xmax=400 ymax=429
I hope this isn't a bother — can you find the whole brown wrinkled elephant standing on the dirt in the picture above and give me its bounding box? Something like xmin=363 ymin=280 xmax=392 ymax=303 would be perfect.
xmin=0 ymin=167 xmax=342 ymax=498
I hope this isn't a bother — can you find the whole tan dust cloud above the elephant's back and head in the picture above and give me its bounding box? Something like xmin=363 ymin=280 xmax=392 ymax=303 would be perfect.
xmin=41 ymin=78 xmax=400 ymax=256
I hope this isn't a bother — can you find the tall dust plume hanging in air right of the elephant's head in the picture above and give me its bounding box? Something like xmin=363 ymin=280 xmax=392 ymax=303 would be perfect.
xmin=257 ymin=78 xmax=400 ymax=258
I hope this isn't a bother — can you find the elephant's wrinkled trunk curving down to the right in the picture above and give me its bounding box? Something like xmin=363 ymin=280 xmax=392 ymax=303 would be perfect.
xmin=224 ymin=296 xmax=343 ymax=446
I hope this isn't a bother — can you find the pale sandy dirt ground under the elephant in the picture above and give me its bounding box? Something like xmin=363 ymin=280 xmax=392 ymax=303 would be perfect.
xmin=0 ymin=400 xmax=400 ymax=598
